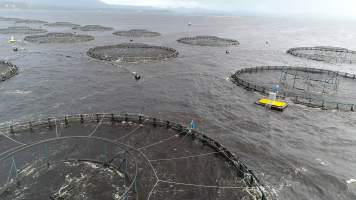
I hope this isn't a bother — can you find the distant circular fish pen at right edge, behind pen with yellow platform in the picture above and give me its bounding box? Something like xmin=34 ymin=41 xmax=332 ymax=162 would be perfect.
xmin=287 ymin=46 xmax=356 ymax=64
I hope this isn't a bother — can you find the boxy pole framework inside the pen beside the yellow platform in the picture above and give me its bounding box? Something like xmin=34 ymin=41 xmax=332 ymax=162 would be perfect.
xmin=280 ymin=68 xmax=340 ymax=94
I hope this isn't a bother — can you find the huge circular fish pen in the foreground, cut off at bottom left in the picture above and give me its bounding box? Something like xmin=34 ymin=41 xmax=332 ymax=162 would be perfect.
xmin=0 ymin=114 xmax=274 ymax=200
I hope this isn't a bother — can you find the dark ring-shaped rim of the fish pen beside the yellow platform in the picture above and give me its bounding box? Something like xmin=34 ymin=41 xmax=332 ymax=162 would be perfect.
xmin=231 ymin=66 xmax=356 ymax=112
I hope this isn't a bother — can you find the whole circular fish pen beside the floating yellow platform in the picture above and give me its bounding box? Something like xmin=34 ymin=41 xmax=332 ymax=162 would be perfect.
xmin=231 ymin=66 xmax=356 ymax=111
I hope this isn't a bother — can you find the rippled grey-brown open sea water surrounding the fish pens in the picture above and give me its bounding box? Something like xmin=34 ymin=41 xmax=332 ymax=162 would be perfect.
xmin=0 ymin=10 xmax=356 ymax=200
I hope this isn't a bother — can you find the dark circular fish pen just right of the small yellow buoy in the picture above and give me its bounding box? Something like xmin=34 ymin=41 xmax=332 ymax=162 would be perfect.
xmin=24 ymin=33 xmax=95 ymax=44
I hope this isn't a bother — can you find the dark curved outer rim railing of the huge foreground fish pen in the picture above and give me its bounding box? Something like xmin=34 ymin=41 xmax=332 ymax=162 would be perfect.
xmin=0 ymin=113 xmax=275 ymax=200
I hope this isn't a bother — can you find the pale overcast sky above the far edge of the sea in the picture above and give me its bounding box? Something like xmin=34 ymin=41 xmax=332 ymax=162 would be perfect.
xmin=101 ymin=0 xmax=356 ymax=17
